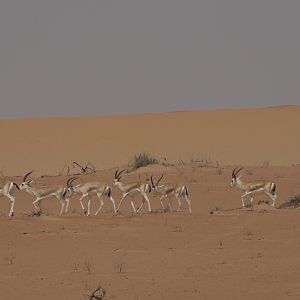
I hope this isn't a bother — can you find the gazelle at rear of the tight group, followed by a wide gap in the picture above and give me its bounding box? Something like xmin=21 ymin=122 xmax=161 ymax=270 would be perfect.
xmin=151 ymin=174 xmax=192 ymax=213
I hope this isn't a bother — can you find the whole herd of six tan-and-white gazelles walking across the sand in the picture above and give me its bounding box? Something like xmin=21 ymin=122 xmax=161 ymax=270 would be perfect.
xmin=0 ymin=168 xmax=277 ymax=217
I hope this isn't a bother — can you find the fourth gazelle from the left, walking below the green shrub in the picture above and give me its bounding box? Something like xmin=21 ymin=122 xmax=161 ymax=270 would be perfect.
xmin=113 ymin=170 xmax=152 ymax=213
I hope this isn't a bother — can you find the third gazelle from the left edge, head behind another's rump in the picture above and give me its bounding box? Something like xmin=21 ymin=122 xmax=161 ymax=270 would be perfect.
xmin=67 ymin=178 xmax=116 ymax=216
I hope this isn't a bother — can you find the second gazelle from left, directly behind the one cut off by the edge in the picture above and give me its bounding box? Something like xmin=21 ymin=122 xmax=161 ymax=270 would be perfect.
xmin=20 ymin=171 xmax=75 ymax=215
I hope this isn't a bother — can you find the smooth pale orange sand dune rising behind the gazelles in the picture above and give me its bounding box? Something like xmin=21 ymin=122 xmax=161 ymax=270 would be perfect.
xmin=0 ymin=106 xmax=300 ymax=175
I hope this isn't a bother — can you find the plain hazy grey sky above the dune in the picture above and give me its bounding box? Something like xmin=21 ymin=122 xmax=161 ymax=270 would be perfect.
xmin=0 ymin=0 xmax=300 ymax=118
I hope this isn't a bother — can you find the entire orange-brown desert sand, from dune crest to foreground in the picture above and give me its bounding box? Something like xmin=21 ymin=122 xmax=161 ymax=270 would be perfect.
xmin=0 ymin=106 xmax=300 ymax=300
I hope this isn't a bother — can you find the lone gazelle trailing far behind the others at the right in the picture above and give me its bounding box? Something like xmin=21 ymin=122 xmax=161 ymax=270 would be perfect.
xmin=230 ymin=168 xmax=277 ymax=207
